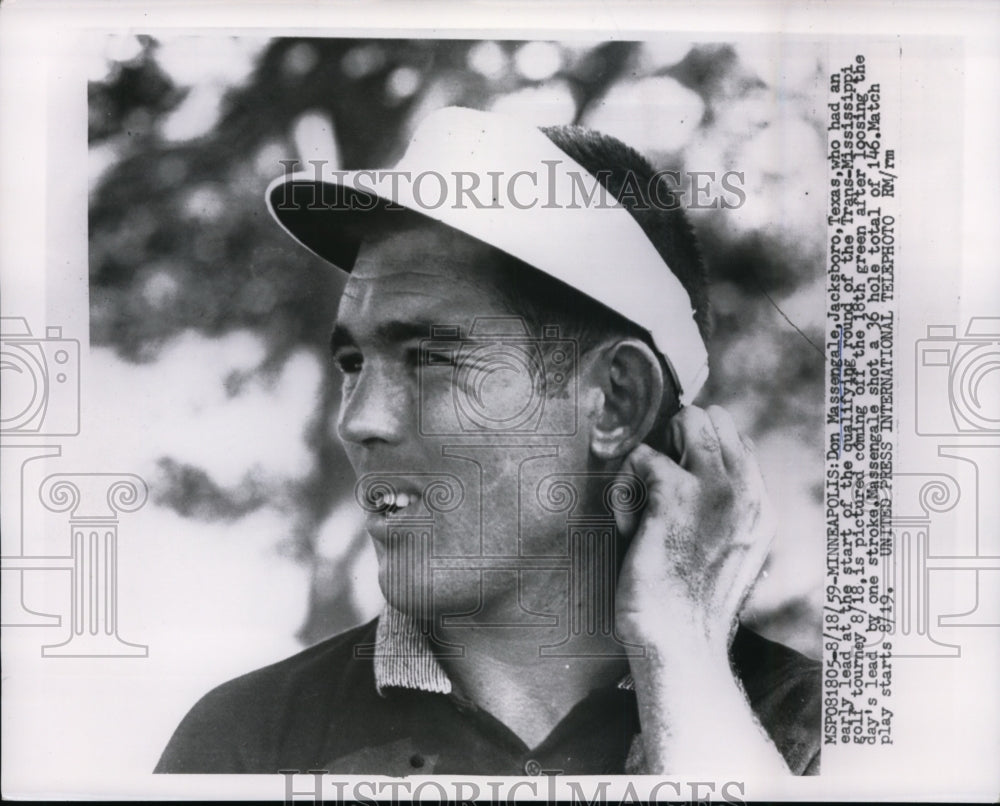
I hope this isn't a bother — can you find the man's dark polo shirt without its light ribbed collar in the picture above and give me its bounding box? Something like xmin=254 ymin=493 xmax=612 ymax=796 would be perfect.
xmin=155 ymin=619 xmax=821 ymax=775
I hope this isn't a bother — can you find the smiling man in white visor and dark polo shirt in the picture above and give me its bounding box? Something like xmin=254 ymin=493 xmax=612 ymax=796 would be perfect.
xmin=157 ymin=109 xmax=820 ymax=775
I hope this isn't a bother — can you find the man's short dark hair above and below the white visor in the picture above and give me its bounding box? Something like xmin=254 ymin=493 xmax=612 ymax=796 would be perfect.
xmin=490 ymin=126 xmax=711 ymax=420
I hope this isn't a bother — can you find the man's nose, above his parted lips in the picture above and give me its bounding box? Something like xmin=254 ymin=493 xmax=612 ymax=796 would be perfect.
xmin=337 ymin=367 xmax=416 ymax=445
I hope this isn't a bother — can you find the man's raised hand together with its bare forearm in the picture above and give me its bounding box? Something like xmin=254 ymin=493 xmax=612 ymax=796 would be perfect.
xmin=615 ymin=406 xmax=788 ymax=775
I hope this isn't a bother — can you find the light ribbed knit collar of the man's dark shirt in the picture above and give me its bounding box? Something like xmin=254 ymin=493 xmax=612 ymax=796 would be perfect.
xmin=375 ymin=604 xmax=635 ymax=695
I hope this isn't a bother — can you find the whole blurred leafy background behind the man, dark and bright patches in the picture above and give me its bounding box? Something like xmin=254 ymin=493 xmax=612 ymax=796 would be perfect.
xmin=85 ymin=36 xmax=826 ymax=664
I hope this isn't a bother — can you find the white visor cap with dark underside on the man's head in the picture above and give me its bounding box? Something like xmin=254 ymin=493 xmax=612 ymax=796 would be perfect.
xmin=267 ymin=107 xmax=708 ymax=405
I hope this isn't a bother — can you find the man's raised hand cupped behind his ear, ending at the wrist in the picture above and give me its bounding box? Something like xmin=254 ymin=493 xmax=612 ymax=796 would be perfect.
xmin=616 ymin=406 xmax=774 ymax=652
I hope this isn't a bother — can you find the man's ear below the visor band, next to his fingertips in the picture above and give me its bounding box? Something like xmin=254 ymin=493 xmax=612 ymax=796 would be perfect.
xmin=590 ymin=339 xmax=663 ymax=461
